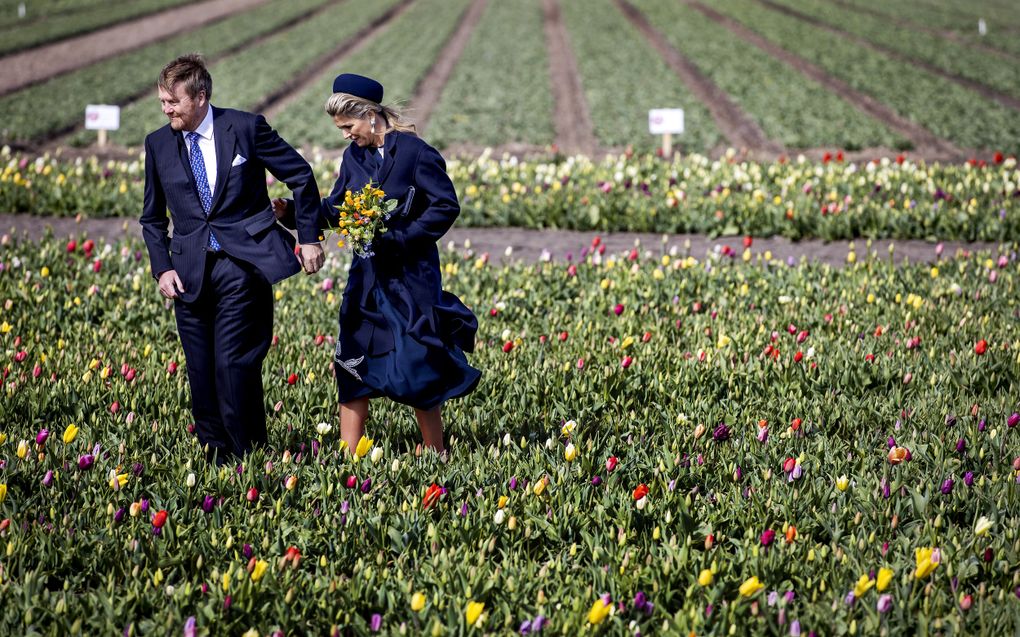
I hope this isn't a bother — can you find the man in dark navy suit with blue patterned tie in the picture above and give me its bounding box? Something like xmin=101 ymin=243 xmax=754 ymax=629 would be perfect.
xmin=141 ymin=55 xmax=323 ymax=463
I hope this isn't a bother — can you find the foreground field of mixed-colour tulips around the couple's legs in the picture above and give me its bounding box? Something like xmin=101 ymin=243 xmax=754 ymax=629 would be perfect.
xmin=0 ymin=222 xmax=1020 ymax=636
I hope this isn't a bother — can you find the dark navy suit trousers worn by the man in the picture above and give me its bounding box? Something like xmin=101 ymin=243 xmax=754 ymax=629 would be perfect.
xmin=174 ymin=251 xmax=273 ymax=460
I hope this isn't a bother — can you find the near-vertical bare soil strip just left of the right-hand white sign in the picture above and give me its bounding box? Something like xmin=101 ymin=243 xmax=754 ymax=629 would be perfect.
xmin=542 ymin=0 xmax=598 ymax=155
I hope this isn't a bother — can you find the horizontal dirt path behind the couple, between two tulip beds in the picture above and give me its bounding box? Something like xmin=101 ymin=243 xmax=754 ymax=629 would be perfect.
xmin=0 ymin=214 xmax=999 ymax=267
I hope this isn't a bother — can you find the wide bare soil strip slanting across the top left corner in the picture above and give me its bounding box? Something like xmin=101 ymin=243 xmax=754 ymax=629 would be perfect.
xmin=0 ymin=0 xmax=268 ymax=96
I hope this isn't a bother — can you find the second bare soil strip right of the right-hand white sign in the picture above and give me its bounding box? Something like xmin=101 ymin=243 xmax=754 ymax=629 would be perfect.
xmin=684 ymin=0 xmax=964 ymax=159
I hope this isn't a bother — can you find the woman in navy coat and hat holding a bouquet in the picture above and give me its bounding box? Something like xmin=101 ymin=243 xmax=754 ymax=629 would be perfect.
xmin=274 ymin=73 xmax=481 ymax=453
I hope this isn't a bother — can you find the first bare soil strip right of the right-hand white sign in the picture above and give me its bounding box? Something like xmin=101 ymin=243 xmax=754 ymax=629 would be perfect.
xmin=616 ymin=0 xmax=782 ymax=155
